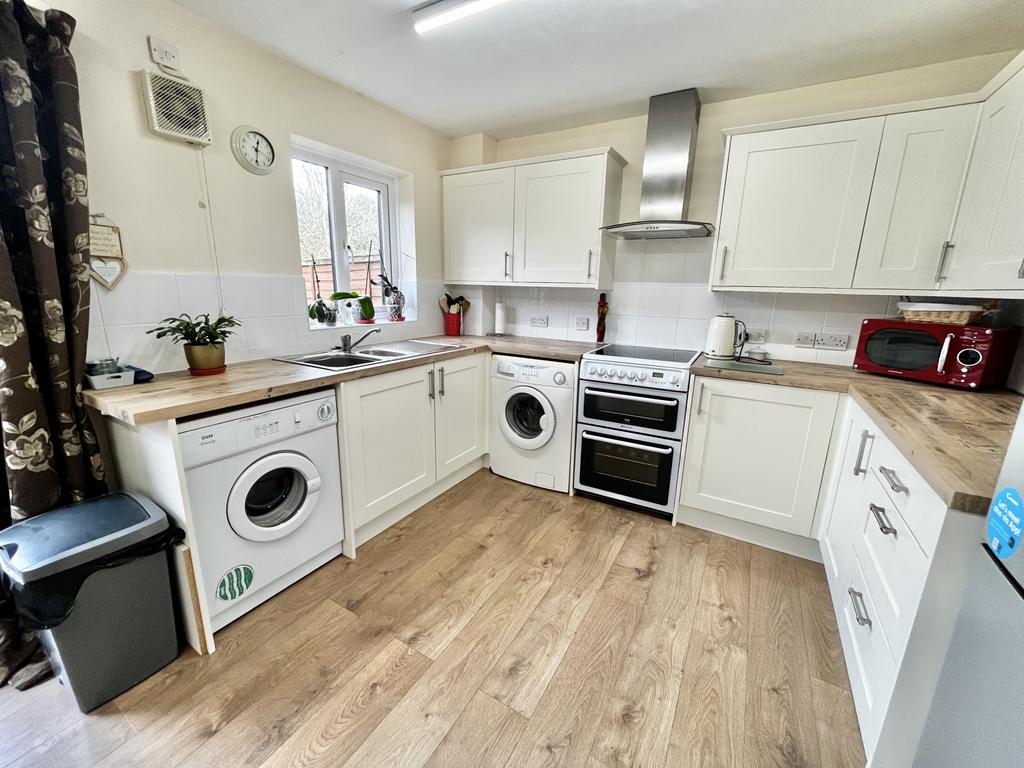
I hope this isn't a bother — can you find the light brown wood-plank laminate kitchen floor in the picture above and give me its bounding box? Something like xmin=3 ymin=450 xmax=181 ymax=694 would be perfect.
xmin=0 ymin=470 xmax=864 ymax=768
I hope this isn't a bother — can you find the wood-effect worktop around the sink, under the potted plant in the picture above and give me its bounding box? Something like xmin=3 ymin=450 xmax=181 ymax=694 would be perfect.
xmin=83 ymin=336 xmax=596 ymax=425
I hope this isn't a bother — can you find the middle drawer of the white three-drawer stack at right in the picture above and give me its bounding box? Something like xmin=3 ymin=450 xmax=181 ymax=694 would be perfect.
xmin=853 ymin=473 xmax=930 ymax=659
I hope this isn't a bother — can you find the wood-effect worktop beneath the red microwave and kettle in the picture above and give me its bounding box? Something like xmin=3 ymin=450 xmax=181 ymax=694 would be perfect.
xmin=691 ymin=357 xmax=1024 ymax=514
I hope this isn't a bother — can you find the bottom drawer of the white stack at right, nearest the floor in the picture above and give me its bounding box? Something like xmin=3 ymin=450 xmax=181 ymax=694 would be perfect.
xmin=837 ymin=558 xmax=897 ymax=755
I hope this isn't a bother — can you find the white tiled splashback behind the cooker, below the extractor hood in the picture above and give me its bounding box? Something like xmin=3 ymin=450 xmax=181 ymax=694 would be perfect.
xmin=498 ymin=239 xmax=896 ymax=366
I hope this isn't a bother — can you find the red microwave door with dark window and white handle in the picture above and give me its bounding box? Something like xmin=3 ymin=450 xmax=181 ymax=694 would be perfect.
xmin=854 ymin=319 xmax=958 ymax=383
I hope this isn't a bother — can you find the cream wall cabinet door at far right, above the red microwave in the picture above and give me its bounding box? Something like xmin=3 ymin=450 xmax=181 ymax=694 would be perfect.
xmin=941 ymin=71 xmax=1024 ymax=290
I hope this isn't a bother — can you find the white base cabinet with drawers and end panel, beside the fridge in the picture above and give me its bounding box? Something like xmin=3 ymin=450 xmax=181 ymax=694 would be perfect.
xmin=821 ymin=399 xmax=983 ymax=766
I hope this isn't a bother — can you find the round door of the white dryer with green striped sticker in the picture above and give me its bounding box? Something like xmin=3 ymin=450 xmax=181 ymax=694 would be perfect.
xmin=227 ymin=451 xmax=322 ymax=542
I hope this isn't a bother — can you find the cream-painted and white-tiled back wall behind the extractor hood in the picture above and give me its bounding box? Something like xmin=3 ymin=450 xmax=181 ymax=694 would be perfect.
xmin=468 ymin=52 xmax=1013 ymax=365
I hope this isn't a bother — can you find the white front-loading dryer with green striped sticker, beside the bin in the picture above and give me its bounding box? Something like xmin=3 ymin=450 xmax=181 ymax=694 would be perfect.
xmin=178 ymin=391 xmax=344 ymax=631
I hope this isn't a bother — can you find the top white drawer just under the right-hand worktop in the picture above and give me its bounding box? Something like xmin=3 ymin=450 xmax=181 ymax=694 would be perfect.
xmin=868 ymin=435 xmax=946 ymax=557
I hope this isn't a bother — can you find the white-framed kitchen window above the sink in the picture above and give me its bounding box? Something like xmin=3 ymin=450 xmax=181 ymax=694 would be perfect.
xmin=292 ymin=150 xmax=403 ymax=314
